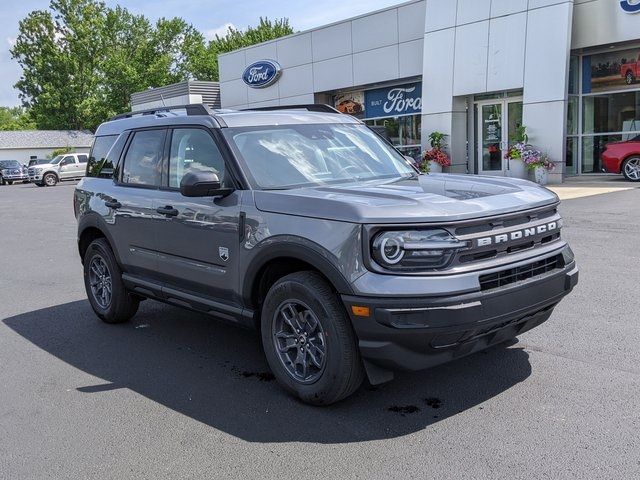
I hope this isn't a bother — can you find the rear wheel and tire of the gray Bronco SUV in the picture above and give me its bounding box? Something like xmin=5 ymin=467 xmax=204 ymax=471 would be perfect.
xmin=84 ymin=238 xmax=140 ymax=323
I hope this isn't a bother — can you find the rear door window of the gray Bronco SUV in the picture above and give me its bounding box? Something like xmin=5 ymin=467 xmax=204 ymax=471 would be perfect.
xmin=122 ymin=130 xmax=165 ymax=186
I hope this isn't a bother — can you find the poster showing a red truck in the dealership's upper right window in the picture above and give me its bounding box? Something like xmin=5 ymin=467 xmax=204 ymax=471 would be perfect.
xmin=582 ymin=48 xmax=640 ymax=93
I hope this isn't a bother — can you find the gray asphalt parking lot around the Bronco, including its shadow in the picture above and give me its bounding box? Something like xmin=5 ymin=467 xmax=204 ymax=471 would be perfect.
xmin=0 ymin=184 xmax=640 ymax=479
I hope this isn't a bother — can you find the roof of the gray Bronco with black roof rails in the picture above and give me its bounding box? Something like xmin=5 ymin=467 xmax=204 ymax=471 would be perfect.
xmin=95 ymin=106 xmax=361 ymax=137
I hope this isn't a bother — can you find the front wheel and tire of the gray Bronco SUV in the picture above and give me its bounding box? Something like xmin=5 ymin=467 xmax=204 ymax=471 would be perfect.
xmin=261 ymin=272 xmax=364 ymax=405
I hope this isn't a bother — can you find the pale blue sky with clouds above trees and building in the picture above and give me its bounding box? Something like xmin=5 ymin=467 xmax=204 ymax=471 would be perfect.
xmin=0 ymin=0 xmax=404 ymax=106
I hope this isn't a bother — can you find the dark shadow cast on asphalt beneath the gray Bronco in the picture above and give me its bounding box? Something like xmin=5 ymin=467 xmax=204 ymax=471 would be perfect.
xmin=4 ymin=301 xmax=531 ymax=444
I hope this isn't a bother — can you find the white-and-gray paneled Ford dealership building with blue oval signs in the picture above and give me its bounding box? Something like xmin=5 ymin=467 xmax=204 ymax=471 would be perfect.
xmin=219 ymin=0 xmax=640 ymax=182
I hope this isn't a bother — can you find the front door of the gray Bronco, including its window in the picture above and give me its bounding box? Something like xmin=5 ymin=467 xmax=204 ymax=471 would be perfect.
xmin=154 ymin=127 xmax=242 ymax=306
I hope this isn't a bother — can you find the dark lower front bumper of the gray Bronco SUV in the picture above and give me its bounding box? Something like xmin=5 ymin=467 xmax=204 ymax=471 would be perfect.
xmin=342 ymin=260 xmax=578 ymax=376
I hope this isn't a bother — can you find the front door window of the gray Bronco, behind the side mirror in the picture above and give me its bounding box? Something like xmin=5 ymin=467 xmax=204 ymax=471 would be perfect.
xmin=169 ymin=128 xmax=225 ymax=188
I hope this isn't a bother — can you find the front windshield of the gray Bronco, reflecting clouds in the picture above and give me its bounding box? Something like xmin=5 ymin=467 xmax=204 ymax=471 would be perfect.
xmin=224 ymin=124 xmax=417 ymax=190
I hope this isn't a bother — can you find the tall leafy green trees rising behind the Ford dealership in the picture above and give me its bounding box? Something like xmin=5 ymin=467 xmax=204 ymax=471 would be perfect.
xmin=11 ymin=0 xmax=293 ymax=130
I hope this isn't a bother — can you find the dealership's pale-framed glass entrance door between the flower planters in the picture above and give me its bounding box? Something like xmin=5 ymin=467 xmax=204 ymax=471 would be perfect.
xmin=477 ymin=98 xmax=522 ymax=175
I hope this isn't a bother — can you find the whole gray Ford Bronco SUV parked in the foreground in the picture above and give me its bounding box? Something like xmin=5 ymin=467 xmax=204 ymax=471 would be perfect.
xmin=74 ymin=105 xmax=578 ymax=404
